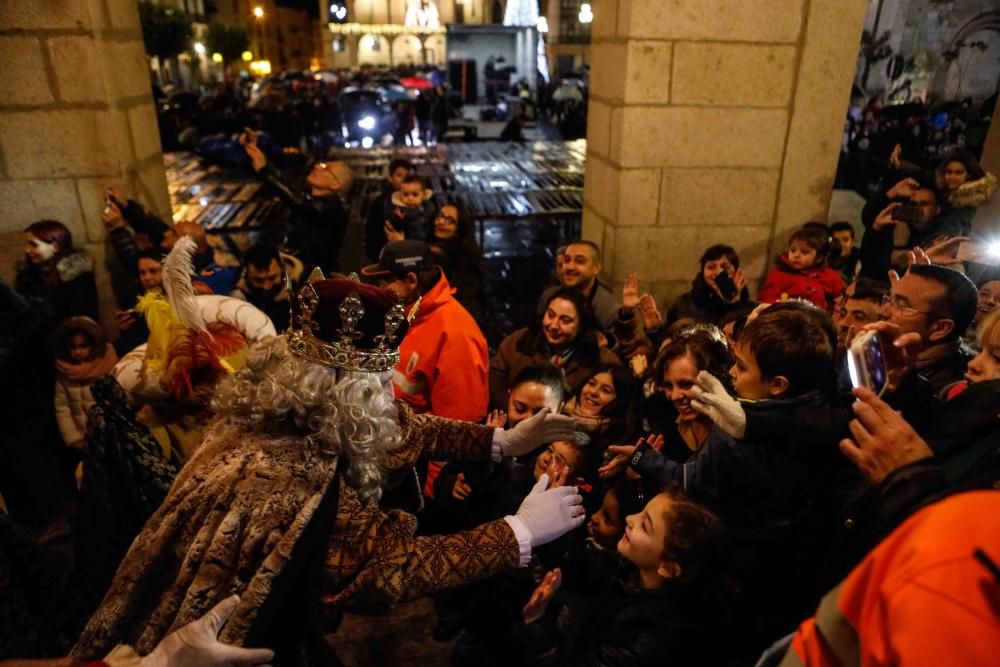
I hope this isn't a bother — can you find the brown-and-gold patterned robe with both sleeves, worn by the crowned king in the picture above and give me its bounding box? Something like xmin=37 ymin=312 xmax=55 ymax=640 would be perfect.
xmin=71 ymin=402 xmax=520 ymax=662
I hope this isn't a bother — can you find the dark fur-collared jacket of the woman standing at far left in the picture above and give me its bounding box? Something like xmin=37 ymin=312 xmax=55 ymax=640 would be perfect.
xmin=15 ymin=250 xmax=98 ymax=323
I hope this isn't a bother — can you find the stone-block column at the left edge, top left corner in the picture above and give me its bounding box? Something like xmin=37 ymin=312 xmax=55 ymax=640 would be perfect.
xmin=0 ymin=0 xmax=170 ymax=331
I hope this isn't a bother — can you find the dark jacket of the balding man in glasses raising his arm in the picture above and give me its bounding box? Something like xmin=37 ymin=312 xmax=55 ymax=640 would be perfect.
xmin=258 ymin=164 xmax=347 ymax=275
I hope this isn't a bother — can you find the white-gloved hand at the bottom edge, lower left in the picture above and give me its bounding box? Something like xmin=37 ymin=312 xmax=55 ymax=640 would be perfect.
xmin=139 ymin=595 xmax=274 ymax=667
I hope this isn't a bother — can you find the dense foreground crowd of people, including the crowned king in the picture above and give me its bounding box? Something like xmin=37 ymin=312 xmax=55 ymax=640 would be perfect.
xmin=0 ymin=122 xmax=1000 ymax=665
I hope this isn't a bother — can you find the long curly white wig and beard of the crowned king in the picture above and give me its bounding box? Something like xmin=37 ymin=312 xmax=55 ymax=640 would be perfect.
xmin=212 ymin=336 xmax=402 ymax=500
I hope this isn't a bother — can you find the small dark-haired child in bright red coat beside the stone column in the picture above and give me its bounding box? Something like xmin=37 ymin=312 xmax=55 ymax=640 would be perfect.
xmin=757 ymin=228 xmax=844 ymax=312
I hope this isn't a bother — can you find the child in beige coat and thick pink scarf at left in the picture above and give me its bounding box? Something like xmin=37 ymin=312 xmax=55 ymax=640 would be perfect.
xmin=53 ymin=317 xmax=118 ymax=450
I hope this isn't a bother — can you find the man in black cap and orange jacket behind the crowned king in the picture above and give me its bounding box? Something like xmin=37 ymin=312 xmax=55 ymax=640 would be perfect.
xmin=361 ymin=240 xmax=490 ymax=497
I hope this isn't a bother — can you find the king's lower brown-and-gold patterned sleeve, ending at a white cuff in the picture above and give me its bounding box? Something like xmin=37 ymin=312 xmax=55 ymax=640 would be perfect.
xmin=322 ymin=485 xmax=520 ymax=613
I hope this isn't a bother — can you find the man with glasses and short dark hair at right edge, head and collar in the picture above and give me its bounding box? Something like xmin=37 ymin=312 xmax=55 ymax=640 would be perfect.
xmin=885 ymin=264 xmax=978 ymax=397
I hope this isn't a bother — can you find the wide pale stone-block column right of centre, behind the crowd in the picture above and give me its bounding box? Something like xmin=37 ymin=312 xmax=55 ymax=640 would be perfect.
xmin=583 ymin=0 xmax=867 ymax=303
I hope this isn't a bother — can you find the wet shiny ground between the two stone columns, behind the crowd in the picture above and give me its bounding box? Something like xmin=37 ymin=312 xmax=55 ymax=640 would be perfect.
xmin=165 ymin=140 xmax=586 ymax=347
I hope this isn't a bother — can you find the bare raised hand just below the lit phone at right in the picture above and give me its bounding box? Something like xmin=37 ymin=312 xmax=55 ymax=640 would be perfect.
xmin=840 ymin=387 xmax=934 ymax=484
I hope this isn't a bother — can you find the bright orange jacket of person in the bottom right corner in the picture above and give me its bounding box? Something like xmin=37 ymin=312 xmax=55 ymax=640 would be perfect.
xmin=781 ymin=491 xmax=1000 ymax=667
